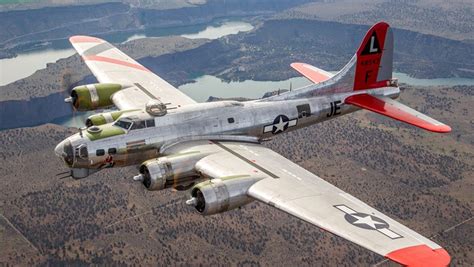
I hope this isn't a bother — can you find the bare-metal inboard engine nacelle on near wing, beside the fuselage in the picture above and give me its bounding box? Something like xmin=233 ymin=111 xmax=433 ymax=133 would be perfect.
xmin=134 ymin=152 xmax=205 ymax=191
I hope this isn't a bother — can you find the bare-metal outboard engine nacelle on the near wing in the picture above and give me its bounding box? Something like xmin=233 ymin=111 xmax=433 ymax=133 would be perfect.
xmin=186 ymin=176 xmax=261 ymax=215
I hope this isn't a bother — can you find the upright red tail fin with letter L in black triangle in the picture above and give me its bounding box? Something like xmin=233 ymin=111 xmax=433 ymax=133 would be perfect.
xmin=353 ymin=22 xmax=393 ymax=90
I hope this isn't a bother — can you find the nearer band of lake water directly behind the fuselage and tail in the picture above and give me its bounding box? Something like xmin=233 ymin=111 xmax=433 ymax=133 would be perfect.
xmin=54 ymin=73 xmax=474 ymax=127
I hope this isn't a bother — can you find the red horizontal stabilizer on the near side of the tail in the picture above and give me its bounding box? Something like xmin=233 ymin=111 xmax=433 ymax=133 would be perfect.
xmin=345 ymin=94 xmax=451 ymax=133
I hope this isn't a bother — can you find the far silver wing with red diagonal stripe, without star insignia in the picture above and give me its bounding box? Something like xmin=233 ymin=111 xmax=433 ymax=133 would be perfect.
xmin=69 ymin=36 xmax=195 ymax=110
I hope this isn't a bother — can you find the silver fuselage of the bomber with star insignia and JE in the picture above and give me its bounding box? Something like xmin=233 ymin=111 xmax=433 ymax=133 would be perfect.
xmin=57 ymin=87 xmax=399 ymax=178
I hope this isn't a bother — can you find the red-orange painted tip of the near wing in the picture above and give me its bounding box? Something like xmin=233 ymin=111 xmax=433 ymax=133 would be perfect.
xmin=385 ymin=245 xmax=451 ymax=266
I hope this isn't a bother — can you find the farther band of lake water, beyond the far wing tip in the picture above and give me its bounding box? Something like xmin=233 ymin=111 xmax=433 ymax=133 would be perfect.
xmin=0 ymin=20 xmax=254 ymax=86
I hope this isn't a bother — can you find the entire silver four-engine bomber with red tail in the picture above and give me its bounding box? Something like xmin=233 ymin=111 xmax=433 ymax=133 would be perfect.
xmin=55 ymin=22 xmax=451 ymax=266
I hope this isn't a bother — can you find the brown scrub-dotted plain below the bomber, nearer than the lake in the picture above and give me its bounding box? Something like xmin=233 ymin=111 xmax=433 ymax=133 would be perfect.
xmin=0 ymin=87 xmax=474 ymax=266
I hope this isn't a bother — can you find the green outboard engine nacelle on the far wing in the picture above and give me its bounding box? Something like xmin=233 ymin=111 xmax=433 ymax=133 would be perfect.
xmin=64 ymin=83 xmax=123 ymax=111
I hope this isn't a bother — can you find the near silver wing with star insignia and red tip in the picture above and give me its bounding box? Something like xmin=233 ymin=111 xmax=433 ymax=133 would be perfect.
xmin=188 ymin=141 xmax=450 ymax=266
